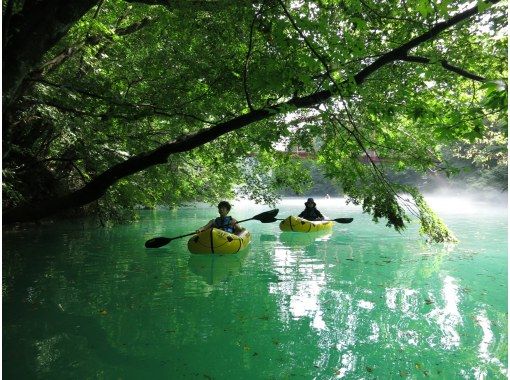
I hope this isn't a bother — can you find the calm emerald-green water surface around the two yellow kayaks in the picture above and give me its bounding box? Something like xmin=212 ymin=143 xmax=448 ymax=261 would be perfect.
xmin=2 ymin=199 xmax=508 ymax=379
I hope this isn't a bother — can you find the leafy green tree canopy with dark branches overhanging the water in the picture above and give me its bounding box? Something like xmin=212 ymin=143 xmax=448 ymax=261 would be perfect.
xmin=3 ymin=0 xmax=507 ymax=241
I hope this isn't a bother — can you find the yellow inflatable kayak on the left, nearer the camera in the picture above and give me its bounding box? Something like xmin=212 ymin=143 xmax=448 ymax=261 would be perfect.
xmin=188 ymin=228 xmax=251 ymax=255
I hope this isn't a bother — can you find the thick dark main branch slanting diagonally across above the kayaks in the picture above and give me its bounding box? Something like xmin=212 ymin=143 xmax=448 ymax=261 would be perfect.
xmin=3 ymin=0 xmax=500 ymax=224
